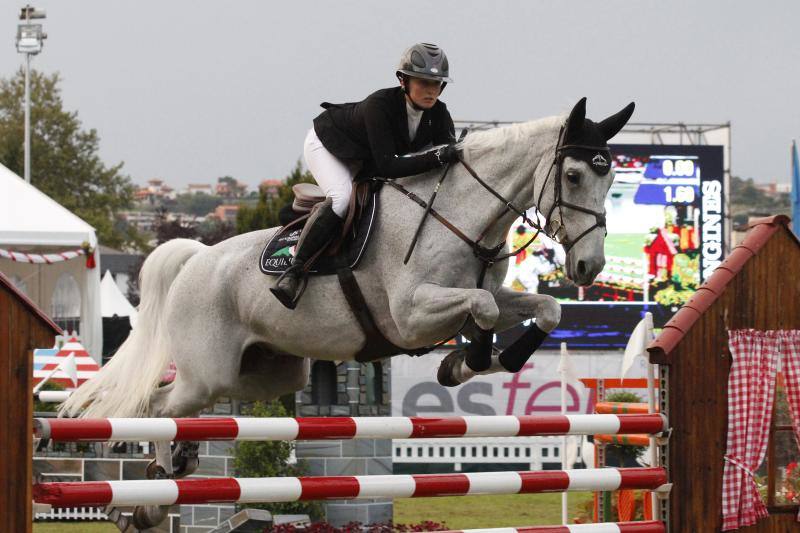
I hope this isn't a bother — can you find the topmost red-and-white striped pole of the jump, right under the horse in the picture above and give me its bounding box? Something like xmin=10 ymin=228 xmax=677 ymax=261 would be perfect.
xmin=34 ymin=414 xmax=669 ymax=442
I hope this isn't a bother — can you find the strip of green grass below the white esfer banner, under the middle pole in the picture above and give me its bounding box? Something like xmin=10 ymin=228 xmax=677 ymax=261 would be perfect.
xmin=394 ymin=492 xmax=592 ymax=529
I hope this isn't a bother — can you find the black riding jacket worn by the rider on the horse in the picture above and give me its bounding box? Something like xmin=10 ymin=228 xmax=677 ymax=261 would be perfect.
xmin=314 ymin=87 xmax=455 ymax=179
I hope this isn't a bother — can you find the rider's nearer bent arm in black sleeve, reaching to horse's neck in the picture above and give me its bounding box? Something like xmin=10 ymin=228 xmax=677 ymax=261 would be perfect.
xmin=364 ymin=98 xmax=444 ymax=178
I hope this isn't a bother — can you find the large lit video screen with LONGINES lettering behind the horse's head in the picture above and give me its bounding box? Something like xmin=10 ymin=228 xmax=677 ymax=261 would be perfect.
xmin=498 ymin=145 xmax=727 ymax=349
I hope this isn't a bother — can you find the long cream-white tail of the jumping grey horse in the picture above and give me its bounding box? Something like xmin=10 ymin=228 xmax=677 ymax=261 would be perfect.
xmin=60 ymin=239 xmax=205 ymax=418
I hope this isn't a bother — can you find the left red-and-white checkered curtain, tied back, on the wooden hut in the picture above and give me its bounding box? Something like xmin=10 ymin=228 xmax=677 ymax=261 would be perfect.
xmin=722 ymin=329 xmax=780 ymax=531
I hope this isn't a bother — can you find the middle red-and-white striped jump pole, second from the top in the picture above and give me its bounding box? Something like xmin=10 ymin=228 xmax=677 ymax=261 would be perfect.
xmin=33 ymin=468 xmax=667 ymax=507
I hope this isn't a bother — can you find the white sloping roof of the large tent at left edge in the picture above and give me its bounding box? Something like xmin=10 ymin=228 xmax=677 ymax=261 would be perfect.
xmin=0 ymin=161 xmax=97 ymax=247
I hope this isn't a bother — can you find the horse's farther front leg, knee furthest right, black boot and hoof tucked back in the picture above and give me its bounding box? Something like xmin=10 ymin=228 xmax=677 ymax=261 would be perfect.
xmin=439 ymin=287 xmax=561 ymax=386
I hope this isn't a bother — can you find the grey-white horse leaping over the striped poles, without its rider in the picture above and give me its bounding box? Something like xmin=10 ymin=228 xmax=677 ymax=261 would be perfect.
xmin=61 ymin=98 xmax=633 ymax=525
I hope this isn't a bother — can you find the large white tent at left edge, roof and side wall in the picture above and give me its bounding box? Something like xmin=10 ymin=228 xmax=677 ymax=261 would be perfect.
xmin=0 ymin=165 xmax=103 ymax=362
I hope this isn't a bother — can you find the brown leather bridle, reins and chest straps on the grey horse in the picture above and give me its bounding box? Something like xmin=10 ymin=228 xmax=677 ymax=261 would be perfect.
xmin=375 ymin=121 xmax=608 ymax=278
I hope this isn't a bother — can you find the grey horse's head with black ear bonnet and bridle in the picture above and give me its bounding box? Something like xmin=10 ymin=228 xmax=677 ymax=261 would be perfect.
xmin=536 ymin=98 xmax=634 ymax=285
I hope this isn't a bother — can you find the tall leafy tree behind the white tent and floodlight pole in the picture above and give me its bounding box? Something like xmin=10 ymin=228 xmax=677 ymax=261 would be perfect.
xmin=0 ymin=69 xmax=136 ymax=247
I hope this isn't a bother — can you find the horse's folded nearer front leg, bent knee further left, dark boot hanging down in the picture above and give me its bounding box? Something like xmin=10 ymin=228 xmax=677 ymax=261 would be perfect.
xmin=393 ymin=283 xmax=500 ymax=386
